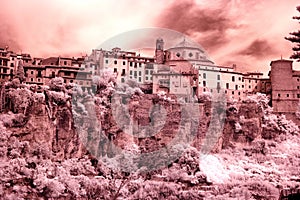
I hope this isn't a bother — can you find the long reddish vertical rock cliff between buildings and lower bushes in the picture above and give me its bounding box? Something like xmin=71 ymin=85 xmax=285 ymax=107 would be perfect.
xmin=1 ymin=80 xmax=298 ymax=159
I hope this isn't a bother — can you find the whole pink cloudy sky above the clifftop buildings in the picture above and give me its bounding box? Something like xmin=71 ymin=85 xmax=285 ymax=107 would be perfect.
xmin=0 ymin=0 xmax=300 ymax=74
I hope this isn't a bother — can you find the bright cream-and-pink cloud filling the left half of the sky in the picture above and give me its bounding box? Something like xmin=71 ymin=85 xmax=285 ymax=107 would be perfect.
xmin=0 ymin=0 xmax=160 ymax=56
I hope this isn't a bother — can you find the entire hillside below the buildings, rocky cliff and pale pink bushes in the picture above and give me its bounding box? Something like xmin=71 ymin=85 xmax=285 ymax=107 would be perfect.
xmin=0 ymin=78 xmax=300 ymax=199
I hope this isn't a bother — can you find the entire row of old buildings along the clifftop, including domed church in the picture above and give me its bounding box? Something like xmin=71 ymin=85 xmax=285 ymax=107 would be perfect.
xmin=0 ymin=38 xmax=300 ymax=113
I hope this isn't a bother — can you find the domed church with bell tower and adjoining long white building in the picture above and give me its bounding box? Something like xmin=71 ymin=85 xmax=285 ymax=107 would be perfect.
xmin=153 ymin=39 xmax=271 ymax=99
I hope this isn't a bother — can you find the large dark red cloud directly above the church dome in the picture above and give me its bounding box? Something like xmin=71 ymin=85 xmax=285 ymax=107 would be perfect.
xmin=157 ymin=0 xmax=238 ymax=50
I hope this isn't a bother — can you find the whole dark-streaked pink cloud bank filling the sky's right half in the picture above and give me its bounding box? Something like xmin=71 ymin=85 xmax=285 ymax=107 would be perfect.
xmin=156 ymin=0 xmax=299 ymax=71
